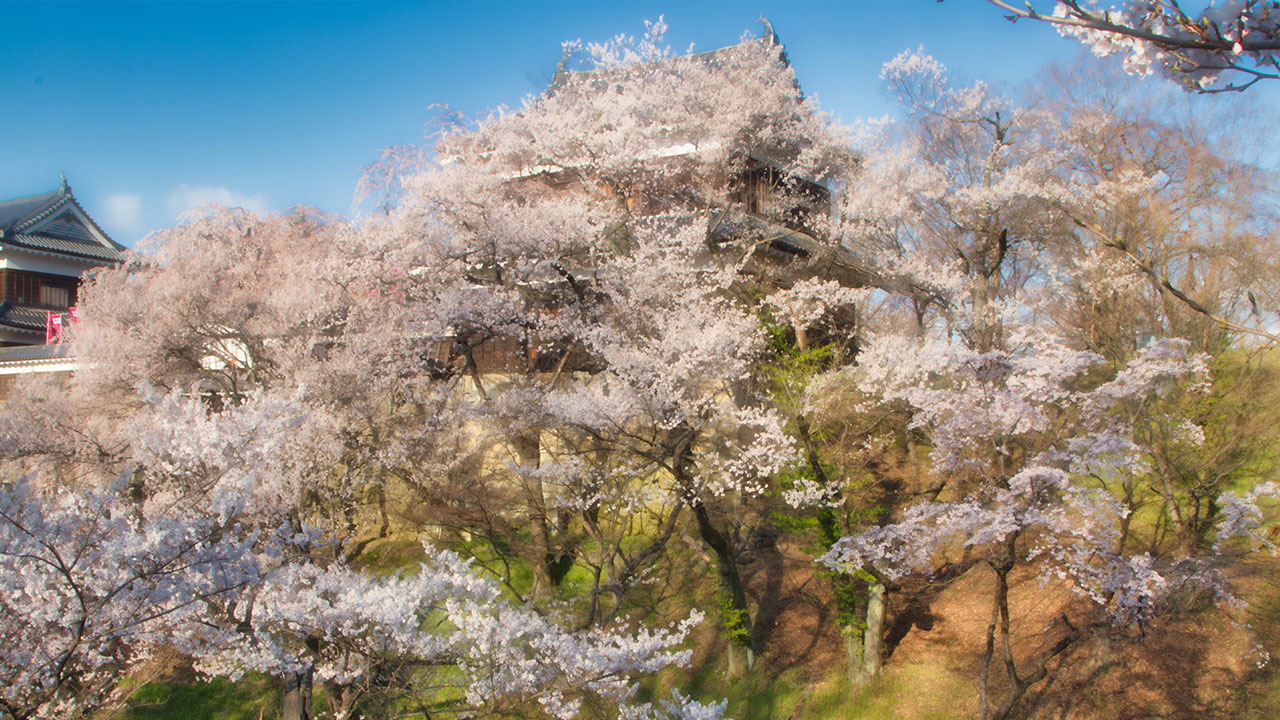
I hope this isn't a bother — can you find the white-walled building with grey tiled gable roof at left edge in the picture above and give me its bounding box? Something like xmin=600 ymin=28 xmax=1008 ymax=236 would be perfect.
xmin=0 ymin=178 xmax=124 ymax=347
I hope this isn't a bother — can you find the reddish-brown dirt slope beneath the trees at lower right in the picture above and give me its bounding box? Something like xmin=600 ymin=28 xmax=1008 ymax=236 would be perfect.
xmin=744 ymin=544 xmax=1280 ymax=720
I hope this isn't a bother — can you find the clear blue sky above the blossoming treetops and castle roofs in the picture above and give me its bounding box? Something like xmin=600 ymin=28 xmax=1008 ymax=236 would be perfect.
xmin=0 ymin=0 xmax=1259 ymax=245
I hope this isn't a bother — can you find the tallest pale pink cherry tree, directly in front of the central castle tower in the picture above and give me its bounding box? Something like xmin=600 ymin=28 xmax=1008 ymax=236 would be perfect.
xmin=371 ymin=22 xmax=852 ymax=664
